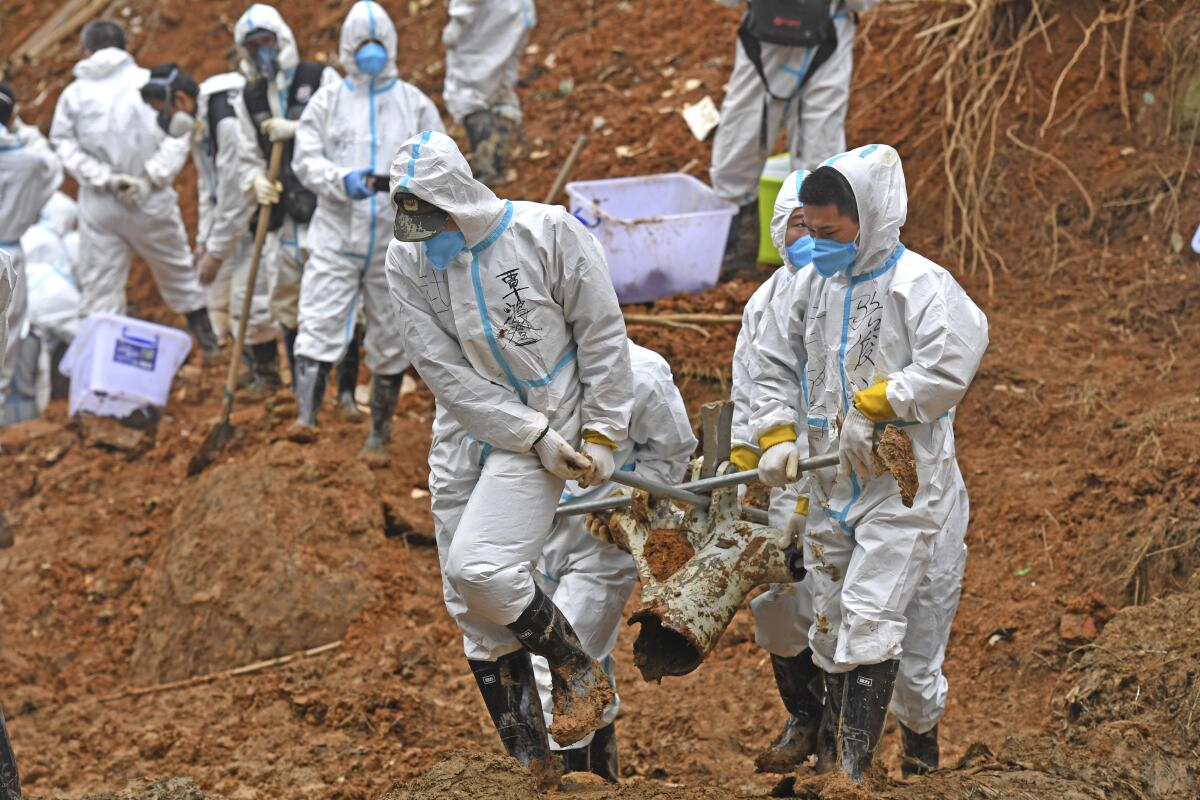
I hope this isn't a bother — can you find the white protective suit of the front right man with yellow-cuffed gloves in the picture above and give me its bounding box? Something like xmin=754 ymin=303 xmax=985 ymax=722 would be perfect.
xmin=752 ymin=145 xmax=988 ymax=733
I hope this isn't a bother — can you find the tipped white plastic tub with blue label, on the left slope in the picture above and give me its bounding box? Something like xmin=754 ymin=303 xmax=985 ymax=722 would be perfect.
xmin=59 ymin=313 xmax=192 ymax=417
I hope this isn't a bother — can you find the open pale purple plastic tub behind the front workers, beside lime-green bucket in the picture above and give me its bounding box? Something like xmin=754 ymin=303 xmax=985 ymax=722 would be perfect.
xmin=566 ymin=173 xmax=738 ymax=303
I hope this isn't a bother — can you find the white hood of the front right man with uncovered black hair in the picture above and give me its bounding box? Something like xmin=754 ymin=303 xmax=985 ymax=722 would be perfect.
xmin=822 ymin=144 xmax=908 ymax=275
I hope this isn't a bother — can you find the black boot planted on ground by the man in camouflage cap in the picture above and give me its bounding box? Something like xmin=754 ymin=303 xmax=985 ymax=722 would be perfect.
xmin=467 ymin=650 xmax=559 ymax=786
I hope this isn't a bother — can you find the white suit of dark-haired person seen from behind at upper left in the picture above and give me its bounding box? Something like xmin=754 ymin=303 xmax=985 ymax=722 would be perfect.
xmin=50 ymin=47 xmax=204 ymax=315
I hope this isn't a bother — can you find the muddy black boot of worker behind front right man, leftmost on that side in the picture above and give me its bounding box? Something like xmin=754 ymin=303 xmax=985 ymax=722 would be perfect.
xmin=755 ymin=649 xmax=823 ymax=775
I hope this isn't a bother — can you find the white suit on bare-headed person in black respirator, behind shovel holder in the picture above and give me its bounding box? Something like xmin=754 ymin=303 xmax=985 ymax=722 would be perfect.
xmin=192 ymin=72 xmax=277 ymax=345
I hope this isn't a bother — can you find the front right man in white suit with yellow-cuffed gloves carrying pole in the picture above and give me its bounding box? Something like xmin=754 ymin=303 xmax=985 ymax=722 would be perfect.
xmin=751 ymin=145 xmax=988 ymax=781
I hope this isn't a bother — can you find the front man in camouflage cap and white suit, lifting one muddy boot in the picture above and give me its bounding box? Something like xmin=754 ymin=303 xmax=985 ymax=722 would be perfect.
xmin=388 ymin=131 xmax=634 ymax=781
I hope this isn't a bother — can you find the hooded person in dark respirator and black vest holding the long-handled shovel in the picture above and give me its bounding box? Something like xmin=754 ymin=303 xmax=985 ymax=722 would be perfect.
xmin=233 ymin=2 xmax=340 ymax=385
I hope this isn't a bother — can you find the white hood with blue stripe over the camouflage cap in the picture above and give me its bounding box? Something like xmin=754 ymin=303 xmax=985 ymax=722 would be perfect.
xmin=389 ymin=131 xmax=504 ymax=247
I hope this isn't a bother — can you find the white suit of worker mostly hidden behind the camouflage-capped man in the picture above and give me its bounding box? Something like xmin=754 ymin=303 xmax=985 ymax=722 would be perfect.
xmin=533 ymin=342 xmax=696 ymax=750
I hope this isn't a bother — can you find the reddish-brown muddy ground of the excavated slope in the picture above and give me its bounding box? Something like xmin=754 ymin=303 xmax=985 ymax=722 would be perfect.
xmin=0 ymin=0 xmax=1200 ymax=800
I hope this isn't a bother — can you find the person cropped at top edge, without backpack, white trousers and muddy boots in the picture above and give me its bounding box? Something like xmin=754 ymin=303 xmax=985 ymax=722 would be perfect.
xmin=442 ymin=0 xmax=538 ymax=186
